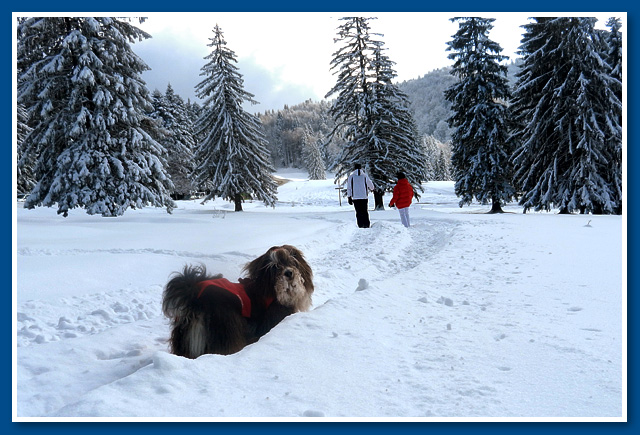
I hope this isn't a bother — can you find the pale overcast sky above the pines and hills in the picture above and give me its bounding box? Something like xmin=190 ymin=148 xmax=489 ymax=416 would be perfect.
xmin=133 ymin=12 xmax=626 ymax=112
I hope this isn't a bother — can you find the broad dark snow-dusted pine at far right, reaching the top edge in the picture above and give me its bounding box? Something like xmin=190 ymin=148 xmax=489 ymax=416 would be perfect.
xmin=510 ymin=17 xmax=622 ymax=213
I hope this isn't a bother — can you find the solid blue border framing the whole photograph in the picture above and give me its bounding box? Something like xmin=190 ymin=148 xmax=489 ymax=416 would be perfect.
xmin=6 ymin=0 xmax=640 ymax=435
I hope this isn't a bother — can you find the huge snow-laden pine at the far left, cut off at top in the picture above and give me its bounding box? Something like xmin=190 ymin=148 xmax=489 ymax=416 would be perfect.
xmin=18 ymin=17 xmax=174 ymax=216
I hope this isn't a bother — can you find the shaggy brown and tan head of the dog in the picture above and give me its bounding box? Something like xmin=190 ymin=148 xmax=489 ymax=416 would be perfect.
xmin=245 ymin=245 xmax=313 ymax=311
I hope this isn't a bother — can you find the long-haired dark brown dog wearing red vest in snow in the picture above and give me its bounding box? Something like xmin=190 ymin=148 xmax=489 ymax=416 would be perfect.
xmin=162 ymin=245 xmax=313 ymax=358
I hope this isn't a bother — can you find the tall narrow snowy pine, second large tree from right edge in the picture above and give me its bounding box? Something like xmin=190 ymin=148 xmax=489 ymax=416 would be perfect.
xmin=445 ymin=17 xmax=515 ymax=213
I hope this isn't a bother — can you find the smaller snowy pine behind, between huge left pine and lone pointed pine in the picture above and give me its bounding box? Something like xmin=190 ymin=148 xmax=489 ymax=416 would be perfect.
xmin=151 ymin=84 xmax=195 ymax=199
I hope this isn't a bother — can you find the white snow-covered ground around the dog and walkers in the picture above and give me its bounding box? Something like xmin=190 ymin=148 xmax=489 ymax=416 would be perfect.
xmin=13 ymin=172 xmax=627 ymax=421
